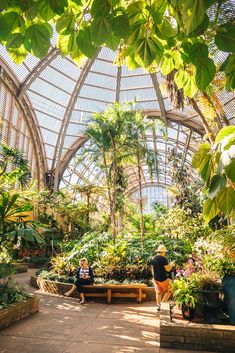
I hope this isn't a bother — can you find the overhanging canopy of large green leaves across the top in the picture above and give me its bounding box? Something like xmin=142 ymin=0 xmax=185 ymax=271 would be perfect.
xmin=0 ymin=0 xmax=235 ymax=92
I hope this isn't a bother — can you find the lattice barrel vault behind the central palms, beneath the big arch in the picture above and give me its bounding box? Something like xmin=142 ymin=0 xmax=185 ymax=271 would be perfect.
xmin=61 ymin=122 xmax=202 ymax=194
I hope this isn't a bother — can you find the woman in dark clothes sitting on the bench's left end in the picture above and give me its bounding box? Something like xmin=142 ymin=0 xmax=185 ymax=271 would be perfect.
xmin=64 ymin=257 xmax=94 ymax=304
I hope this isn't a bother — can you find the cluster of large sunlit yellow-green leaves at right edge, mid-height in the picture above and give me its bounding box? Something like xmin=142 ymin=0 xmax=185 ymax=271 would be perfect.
xmin=192 ymin=126 xmax=235 ymax=222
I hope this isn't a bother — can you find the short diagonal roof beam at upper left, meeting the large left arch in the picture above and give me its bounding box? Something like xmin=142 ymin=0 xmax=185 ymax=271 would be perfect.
xmin=18 ymin=48 xmax=60 ymax=100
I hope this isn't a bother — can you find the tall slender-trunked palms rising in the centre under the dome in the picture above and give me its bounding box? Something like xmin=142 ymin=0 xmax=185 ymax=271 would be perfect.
xmin=82 ymin=103 xmax=157 ymax=244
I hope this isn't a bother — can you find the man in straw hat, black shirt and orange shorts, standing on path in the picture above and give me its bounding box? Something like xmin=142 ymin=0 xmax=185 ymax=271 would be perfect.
xmin=152 ymin=245 xmax=175 ymax=311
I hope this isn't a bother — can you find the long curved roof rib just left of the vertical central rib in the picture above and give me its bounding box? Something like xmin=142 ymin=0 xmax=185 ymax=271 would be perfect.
xmin=51 ymin=51 xmax=99 ymax=191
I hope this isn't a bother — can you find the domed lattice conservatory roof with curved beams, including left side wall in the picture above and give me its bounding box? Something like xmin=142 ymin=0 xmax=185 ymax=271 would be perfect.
xmin=0 ymin=47 xmax=235 ymax=201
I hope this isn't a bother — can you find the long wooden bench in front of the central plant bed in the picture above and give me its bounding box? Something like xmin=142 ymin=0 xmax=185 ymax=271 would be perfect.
xmin=83 ymin=283 xmax=147 ymax=304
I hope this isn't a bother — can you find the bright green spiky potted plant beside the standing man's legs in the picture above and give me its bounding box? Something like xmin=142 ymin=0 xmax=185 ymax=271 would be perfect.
xmin=173 ymin=278 xmax=200 ymax=320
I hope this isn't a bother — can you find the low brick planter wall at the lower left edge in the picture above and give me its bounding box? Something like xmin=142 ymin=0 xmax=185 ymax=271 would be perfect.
xmin=0 ymin=296 xmax=39 ymax=329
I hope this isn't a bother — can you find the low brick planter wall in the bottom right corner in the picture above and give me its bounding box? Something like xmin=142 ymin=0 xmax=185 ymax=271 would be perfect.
xmin=160 ymin=303 xmax=235 ymax=353
